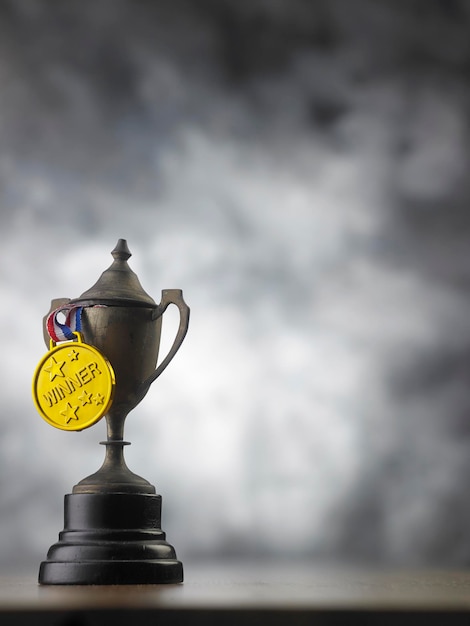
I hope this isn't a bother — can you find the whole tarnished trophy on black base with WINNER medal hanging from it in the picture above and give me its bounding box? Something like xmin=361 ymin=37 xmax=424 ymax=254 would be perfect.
xmin=33 ymin=239 xmax=189 ymax=585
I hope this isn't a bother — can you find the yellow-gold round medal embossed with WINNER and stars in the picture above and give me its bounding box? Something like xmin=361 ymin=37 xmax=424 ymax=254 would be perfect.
xmin=33 ymin=332 xmax=115 ymax=430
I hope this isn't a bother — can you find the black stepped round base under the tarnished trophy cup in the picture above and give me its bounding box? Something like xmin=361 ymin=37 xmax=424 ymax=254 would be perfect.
xmin=39 ymin=493 xmax=183 ymax=585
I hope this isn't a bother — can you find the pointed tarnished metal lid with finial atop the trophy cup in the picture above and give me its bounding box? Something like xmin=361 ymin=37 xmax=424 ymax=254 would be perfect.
xmin=70 ymin=239 xmax=157 ymax=308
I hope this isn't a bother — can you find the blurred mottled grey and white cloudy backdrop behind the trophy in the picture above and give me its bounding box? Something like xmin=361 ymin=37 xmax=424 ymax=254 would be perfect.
xmin=0 ymin=0 xmax=470 ymax=571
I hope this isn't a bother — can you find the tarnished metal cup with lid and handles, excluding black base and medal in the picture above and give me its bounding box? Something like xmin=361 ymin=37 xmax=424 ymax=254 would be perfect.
xmin=44 ymin=239 xmax=189 ymax=493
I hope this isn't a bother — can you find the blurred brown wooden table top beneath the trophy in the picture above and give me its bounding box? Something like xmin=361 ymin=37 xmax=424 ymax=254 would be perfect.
xmin=0 ymin=562 xmax=470 ymax=626
